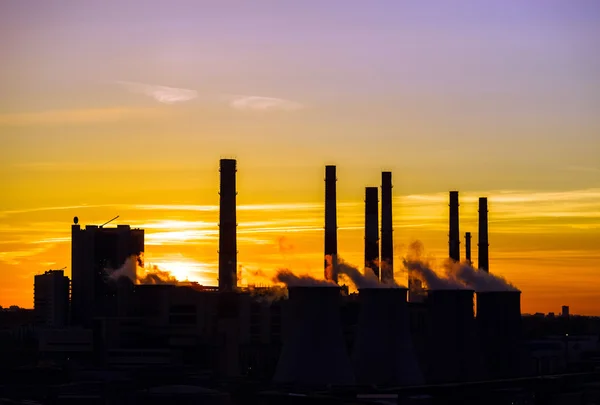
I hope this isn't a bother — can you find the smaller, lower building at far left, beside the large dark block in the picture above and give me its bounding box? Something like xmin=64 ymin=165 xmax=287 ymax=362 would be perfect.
xmin=33 ymin=270 xmax=70 ymax=328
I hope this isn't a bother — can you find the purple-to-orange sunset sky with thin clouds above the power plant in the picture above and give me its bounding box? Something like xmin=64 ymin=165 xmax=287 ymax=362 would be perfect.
xmin=0 ymin=0 xmax=600 ymax=315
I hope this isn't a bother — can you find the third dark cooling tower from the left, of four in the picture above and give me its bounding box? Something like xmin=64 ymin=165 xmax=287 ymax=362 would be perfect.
xmin=427 ymin=290 xmax=481 ymax=384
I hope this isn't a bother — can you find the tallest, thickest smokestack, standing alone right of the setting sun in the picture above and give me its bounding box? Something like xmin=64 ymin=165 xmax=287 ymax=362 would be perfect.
xmin=219 ymin=159 xmax=237 ymax=291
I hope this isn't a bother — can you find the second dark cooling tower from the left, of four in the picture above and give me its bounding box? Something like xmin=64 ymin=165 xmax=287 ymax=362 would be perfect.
xmin=352 ymin=288 xmax=423 ymax=386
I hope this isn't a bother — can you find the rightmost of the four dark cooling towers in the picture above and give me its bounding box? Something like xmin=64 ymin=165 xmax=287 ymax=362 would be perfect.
xmin=476 ymin=291 xmax=522 ymax=378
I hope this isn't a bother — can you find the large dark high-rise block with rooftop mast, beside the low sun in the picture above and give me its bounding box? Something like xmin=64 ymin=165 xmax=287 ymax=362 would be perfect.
xmin=71 ymin=217 xmax=144 ymax=326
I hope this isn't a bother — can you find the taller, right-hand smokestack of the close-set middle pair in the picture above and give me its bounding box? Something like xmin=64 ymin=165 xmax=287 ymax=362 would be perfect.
xmin=381 ymin=172 xmax=394 ymax=284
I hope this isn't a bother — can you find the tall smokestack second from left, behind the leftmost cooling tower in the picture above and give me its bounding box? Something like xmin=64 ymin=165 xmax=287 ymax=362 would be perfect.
xmin=325 ymin=166 xmax=338 ymax=283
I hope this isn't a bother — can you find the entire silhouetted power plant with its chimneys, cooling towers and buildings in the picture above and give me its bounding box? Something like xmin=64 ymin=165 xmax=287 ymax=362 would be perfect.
xmin=2 ymin=159 xmax=596 ymax=404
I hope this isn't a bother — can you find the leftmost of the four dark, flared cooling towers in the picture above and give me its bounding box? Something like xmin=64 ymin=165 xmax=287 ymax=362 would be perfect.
xmin=273 ymin=286 xmax=354 ymax=385
